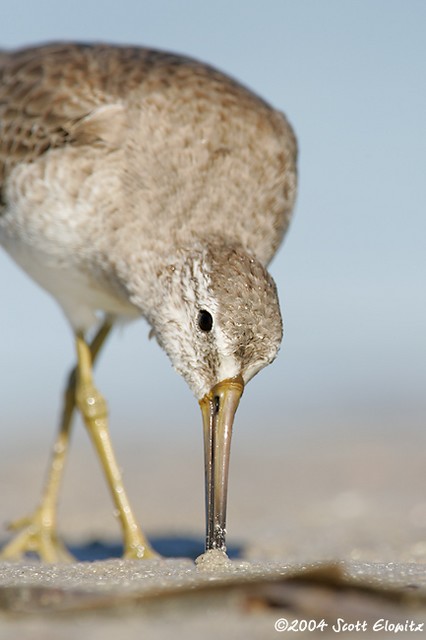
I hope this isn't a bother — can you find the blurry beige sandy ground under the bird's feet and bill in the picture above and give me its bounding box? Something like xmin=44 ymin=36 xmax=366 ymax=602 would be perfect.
xmin=0 ymin=428 xmax=426 ymax=640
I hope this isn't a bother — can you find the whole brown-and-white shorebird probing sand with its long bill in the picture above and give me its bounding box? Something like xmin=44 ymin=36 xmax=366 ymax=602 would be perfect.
xmin=0 ymin=43 xmax=296 ymax=562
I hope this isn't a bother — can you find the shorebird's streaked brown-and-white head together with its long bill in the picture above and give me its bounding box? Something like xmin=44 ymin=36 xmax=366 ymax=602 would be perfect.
xmin=146 ymin=245 xmax=282 ymax=549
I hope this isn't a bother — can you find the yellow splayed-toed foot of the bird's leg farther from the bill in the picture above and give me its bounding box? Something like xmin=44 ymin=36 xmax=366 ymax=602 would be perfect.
xmin=0 ymin=508 xmax=74 ymax=563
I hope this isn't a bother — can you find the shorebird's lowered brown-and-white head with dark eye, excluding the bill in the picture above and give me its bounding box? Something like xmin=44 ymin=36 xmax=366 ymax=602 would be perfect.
xmin=152 ymin=245 xmax=282 ymax=400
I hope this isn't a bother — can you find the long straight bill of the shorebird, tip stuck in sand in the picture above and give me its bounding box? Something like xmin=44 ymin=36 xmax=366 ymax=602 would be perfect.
xmin=200 ymin=376 xmax=244 ymax=551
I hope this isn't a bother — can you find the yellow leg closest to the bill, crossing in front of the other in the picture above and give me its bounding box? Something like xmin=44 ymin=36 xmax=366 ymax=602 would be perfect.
xmin=75 ymin=333 xmax=157 ymax=558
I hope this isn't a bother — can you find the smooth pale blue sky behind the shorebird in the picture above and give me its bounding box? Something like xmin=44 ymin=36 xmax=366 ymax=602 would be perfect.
xmin=0 ymin=0 xmax=426 ymax=448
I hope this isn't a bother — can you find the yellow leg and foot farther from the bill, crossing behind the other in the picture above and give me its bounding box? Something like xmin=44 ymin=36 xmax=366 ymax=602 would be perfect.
xmin=0 ymin=320 xmax=112 ymax=562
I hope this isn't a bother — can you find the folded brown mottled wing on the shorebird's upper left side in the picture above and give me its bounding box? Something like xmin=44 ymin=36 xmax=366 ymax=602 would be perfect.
xmin=0 ymin=44 xmax=181 ymax=201
